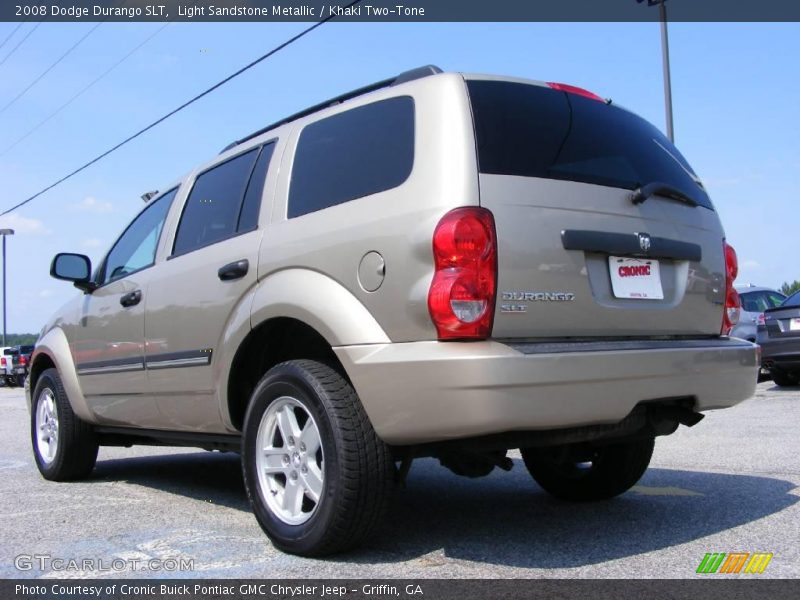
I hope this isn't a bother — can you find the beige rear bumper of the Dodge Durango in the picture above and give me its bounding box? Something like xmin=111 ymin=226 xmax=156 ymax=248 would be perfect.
xmin=335 ymin=338 xmax=759 ymax=445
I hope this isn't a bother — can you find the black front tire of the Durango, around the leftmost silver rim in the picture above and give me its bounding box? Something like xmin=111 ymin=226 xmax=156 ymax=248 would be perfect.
xmin=31 ymin=369 xmax=98 ymax=481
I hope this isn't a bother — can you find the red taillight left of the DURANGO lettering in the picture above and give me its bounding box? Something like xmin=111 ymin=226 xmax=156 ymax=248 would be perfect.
xmin=428 ymin=207 xmax=497 ymax=340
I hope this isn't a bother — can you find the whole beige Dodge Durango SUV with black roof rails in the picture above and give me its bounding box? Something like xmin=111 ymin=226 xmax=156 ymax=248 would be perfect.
xmin=26 ymin=67 xmax=760 ymax=556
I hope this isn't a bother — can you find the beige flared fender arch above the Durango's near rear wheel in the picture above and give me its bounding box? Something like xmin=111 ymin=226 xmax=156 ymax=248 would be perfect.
xmin=250 ymin=269 xmax=390 ymax=347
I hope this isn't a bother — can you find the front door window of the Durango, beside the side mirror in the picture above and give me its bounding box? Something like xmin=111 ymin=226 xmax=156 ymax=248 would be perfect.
xmin=101 ymin=188 xmax=178 ymax=283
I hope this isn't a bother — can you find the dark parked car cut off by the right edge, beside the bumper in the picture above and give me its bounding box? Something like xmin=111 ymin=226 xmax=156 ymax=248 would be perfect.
xmin=758 ymin=292 xmax=800 ymax=387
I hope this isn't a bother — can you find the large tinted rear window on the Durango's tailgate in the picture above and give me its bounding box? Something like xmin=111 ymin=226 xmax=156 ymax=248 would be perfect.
xmin=467 ymin=80 xmax=712 ymax=208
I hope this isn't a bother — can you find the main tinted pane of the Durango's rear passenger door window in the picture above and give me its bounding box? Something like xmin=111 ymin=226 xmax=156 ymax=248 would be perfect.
xmin=172 ymin=148 xmax=259 ymax=255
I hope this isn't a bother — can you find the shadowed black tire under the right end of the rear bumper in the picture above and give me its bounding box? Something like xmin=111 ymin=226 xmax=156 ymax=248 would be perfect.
xmin=521 ymin=438 xmax=655 ymax=502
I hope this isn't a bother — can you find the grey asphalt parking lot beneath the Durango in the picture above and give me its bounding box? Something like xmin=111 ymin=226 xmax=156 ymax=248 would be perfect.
xmin=0 ymin=381 xmax=800 ymax=578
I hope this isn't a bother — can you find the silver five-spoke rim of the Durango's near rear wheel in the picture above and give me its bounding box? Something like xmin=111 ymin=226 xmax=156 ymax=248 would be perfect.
xmin=256 ymin=396 xmax=325 ymax=525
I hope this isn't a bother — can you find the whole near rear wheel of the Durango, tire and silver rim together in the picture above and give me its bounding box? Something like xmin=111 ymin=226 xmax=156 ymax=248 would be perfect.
xmin=242 ymin=360 xmax=394 ymax=556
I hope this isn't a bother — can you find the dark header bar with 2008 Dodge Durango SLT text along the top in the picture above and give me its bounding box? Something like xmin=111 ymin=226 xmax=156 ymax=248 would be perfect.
xmin=0 ymin=0 xmax=800 ymax=22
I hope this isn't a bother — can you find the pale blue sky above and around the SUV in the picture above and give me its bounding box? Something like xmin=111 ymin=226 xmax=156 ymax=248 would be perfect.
xmin=0 ymin=23 xmax=800 ymax=333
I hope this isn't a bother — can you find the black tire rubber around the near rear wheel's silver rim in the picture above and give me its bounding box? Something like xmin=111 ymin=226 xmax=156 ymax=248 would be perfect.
xmin=242 ymin=360 xmax=394 ymax=556
